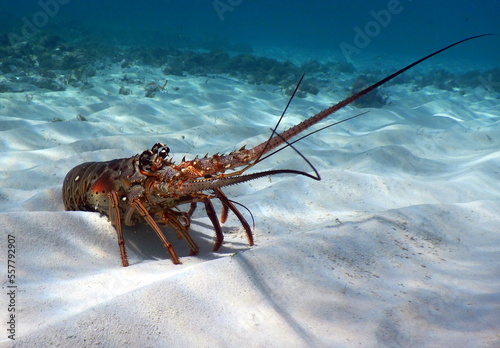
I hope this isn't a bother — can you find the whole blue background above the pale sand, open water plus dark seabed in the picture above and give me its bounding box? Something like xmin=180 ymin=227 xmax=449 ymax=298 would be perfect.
xmin=0 ymin=0 xmax=500 ymax=98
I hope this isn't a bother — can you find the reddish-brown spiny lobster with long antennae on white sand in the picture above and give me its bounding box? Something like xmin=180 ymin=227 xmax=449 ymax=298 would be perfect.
xmin=63 ymin=34 xmax=491 ymax=267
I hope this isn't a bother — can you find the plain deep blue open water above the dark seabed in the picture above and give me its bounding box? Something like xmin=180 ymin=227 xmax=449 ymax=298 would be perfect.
xmin=0 ymin=0 xmax=500 ymax=67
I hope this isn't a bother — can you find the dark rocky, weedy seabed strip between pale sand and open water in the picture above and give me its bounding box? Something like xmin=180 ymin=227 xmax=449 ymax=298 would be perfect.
xmin=0 ymin=34 xmax=500 ymax=103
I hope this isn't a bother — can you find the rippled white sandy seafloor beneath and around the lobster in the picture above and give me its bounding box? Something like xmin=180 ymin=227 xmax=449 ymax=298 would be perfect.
xmin=0 ymin=58 xmax=500 ymax=347
